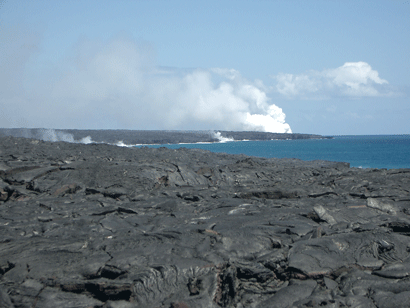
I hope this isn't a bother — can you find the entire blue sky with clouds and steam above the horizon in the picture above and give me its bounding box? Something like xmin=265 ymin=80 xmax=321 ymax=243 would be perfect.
xmin=0 ymin=0 xmax=410 ymax=135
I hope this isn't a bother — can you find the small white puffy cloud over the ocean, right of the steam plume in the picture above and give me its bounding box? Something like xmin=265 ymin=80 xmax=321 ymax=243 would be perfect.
xmin=274 ymin=62 xmax=392 ymax=99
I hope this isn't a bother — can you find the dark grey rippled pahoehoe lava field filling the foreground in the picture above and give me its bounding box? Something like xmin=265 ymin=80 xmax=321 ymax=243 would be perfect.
xmin=0 ymin=137 xmax=410 ymax=308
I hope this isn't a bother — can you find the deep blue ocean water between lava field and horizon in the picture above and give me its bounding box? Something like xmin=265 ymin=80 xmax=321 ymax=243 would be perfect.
xmin=137 ymin=135 xmax=410 ymax=169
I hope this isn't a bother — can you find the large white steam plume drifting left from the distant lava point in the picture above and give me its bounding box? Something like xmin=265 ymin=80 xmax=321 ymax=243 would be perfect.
xmin=0 ymin=33 xmax=292 ymax=133
